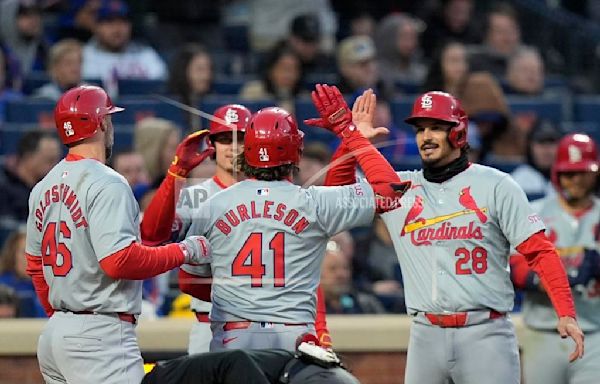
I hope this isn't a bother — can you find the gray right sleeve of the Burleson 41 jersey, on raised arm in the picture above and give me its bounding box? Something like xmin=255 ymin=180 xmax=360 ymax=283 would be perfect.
xmin=309 ymin=182 xmax=375 ymax=236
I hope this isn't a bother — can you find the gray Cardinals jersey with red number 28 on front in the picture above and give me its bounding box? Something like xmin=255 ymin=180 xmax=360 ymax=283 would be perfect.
xmin=382 ymin=164 xmax=544 ymax=314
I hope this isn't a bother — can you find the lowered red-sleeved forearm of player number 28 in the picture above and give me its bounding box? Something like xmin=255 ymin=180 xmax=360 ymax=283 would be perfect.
xmin=517 ymin=231 xmax=575 ymax=318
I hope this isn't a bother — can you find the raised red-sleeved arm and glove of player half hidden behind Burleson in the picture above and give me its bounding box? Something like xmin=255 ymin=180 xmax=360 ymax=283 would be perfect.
xmin=140 ymin=130 xmax=215 ymax=245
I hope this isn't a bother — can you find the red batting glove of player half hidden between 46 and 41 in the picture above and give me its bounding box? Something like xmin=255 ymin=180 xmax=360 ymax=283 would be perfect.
xmin=169 ymin=129 xmax=215 ymax=177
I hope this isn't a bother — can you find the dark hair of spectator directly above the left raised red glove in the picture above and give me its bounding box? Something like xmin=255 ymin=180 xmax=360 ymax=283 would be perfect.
xmin=167 ymin=43 xmax=212 ymax=105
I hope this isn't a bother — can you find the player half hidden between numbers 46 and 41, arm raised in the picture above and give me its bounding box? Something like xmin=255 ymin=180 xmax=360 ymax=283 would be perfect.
xmin=140 ymin=104 xmax=252 ymax=354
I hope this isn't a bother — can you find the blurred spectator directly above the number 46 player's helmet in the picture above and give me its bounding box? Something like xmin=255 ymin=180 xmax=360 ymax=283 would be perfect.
xmin=33 ymin=39 xmax=83 ymax=101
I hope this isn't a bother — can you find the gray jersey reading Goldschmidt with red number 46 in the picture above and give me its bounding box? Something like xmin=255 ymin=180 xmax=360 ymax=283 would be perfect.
xmin=26 ymin=159 xmax=142 ymax=314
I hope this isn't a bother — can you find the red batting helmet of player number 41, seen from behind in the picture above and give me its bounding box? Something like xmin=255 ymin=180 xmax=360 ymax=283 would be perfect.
xmin=244 ymin=107 xmax=304 ymax=168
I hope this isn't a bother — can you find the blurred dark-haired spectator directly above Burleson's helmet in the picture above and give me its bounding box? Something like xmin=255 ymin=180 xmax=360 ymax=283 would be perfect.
xmin=240 ymin=45 xmax=303 ymax=113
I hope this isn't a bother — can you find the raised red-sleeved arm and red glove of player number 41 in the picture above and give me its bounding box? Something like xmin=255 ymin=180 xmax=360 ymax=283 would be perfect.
xmin=304 ymin=84 xmax=410 ymax=213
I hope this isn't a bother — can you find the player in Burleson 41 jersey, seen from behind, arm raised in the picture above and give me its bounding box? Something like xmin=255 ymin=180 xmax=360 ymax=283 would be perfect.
xmin=166 ymin=85 xmax=406 ymax=351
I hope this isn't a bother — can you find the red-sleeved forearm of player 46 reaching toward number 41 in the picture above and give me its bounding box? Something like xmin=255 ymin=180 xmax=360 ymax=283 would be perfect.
xmin=100 ymin=243 xmax=185 ymax=280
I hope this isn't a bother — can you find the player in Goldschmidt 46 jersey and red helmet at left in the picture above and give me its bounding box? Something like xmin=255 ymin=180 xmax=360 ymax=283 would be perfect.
xmin=26 ymin=86 xmax=210 ymax=384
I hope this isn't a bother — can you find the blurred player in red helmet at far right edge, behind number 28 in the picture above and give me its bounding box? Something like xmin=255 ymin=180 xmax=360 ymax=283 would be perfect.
xmin=510 ymin=134 xmax=600 ymax=384
